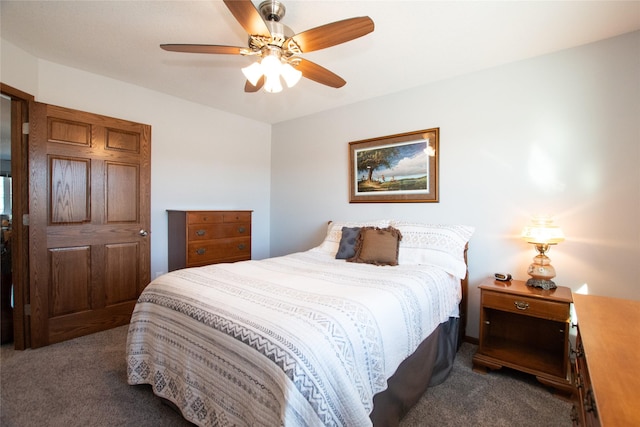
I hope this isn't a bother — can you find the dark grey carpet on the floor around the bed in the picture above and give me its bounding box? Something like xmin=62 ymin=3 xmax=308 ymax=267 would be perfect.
xmin=0 ymin=326 xmax=571 ymax=427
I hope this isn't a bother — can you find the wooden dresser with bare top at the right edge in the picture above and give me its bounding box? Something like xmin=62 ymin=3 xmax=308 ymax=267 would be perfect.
xmin=571 ymin=294 xmax=640 ymax=427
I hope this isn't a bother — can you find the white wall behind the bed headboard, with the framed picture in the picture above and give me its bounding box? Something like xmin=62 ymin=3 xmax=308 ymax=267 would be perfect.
xmin=271 ymin=32 xmax=640 ymax=337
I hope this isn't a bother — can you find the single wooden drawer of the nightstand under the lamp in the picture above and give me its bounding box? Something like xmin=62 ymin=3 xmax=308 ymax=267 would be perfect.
xmin=482 ymin=290 xmax=570 ymax=322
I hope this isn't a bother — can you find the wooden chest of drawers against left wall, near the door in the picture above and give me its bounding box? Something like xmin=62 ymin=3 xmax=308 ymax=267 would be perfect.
xmin=167 ymin=210 xmax=252 ymax=271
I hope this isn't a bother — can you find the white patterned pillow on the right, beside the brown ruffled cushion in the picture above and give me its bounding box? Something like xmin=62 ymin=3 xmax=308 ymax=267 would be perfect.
xmin=390 ymin=221 xmax=475 ymax=279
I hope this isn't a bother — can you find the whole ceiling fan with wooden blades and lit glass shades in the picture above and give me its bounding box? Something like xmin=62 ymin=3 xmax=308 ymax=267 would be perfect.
xmin=160 ymin=0 xmax=374 ymax=93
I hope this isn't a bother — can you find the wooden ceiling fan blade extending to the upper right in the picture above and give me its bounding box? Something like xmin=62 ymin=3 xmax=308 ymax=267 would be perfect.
xmin=285 ymin=16 xmax=374 ymax=52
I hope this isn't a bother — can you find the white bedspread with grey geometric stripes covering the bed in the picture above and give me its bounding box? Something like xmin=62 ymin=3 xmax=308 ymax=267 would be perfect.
xmin=127 ymin=250 xmax=460 ymax=427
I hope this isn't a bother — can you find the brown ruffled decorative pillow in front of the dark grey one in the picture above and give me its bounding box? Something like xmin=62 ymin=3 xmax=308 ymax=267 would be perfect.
xmin=347 ymin=227 xmax=402 ymax=265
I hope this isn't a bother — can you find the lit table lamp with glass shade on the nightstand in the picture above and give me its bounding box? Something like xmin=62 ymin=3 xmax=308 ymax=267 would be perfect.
xmin=522 ymin=217 xmax=564 ymax=289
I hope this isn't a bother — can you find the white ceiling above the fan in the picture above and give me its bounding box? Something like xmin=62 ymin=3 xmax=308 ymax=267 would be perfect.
xmin=0 ymin=0 xmax=640 ymax=123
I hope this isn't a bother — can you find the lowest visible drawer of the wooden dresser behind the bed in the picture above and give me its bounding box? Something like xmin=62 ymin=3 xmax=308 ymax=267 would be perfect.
xmin=187 ymin=237 xmax=251 ymax=267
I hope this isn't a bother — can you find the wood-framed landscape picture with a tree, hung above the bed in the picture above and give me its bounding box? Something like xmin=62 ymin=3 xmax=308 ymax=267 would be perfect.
xmin=349 ymin=128 xmax=440 ymax=203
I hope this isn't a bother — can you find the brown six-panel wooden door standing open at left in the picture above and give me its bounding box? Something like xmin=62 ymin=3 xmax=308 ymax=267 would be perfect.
xmin=29 ymin=102 xmax=151 ymax=347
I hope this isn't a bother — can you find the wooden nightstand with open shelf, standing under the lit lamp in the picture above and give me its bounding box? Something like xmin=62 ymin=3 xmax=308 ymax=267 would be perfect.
xmin=473 ymin=279 xmax=573 ymax=395
